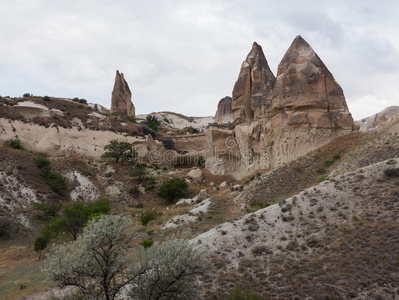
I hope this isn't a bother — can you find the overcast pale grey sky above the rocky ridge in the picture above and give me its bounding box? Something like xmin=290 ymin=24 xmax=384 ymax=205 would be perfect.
xmin=0 ymin=0 xmax=399 ymax=119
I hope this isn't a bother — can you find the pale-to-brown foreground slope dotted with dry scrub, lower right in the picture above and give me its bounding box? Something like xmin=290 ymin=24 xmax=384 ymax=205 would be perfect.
xmin=194 ymin=159 xmax=399 ymax=299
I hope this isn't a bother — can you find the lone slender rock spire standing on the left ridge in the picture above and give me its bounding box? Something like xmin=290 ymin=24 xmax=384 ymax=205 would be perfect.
xmin=110 ymin=70 xmax=136 ymax=117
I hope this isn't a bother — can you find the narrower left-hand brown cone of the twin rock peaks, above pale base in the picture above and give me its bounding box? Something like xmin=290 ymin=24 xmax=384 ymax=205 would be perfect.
xmin=233 ymin=42 xmax=275 ymax=124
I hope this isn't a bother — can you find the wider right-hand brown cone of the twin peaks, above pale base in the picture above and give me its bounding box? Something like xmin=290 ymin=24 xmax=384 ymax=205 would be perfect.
xmin=272 ymin=36 xmax=353 ymax=130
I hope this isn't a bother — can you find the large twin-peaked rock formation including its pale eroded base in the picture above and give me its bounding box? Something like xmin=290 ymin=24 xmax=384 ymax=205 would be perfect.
xmin=205 ymin=36 xmax=354 ymax=177
